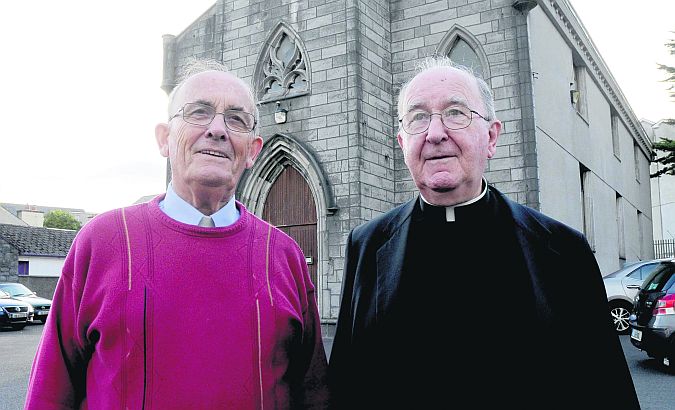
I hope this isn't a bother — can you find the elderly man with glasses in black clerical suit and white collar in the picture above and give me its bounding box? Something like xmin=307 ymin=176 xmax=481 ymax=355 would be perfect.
xmin=329 ymin=58 xmax=639 ymax=409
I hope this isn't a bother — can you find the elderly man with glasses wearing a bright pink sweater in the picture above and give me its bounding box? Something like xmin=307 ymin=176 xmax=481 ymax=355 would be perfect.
xmin=25 ymin=62 xmax=328 ymax=410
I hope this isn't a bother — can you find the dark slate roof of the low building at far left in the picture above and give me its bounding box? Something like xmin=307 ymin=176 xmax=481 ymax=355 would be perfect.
xmin=0 ymin=224 xmax=77 ymax=256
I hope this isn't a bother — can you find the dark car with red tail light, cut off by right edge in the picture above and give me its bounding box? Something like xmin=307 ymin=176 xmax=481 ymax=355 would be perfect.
xmin=629 ymin=259 xmax=675 ymax=369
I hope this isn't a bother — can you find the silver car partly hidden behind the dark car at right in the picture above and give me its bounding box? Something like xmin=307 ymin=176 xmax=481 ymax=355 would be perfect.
xmin=602 ymin=259 xmax=670 ymax=334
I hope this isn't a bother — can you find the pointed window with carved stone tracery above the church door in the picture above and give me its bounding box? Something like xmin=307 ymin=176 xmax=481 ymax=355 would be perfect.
xmin=255 ymin=21 xmax=311 ymax=103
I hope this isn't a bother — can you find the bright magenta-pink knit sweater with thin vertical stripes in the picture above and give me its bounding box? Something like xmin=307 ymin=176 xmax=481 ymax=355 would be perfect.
xmin=26 ymin=196 xmax=327 ymax=410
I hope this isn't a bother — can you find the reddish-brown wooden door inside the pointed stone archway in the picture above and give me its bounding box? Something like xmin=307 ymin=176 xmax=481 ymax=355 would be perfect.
xmin=263 ymin=166 xmax=318 ymax=294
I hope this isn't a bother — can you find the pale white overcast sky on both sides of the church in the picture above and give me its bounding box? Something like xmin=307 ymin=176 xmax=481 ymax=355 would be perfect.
xmin=0 ymin=0 xmax=675 ymax=213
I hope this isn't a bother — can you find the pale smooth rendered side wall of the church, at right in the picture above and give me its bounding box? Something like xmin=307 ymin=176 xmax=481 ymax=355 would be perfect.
xmin=529 ymin=7 xmax=653 ymax=274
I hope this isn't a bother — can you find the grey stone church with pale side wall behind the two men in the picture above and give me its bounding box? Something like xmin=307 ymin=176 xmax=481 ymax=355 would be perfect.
xmin=162 ymin=0 xmax=653 ymax=324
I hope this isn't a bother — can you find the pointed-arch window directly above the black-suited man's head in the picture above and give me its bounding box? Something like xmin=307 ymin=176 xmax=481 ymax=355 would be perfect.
xmin=436 ymin=25 xmax=490 ymax=80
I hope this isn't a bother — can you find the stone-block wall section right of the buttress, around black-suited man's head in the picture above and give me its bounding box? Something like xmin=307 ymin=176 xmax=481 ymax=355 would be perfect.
xmin=391 ymin=0 xmax=539 ymax=208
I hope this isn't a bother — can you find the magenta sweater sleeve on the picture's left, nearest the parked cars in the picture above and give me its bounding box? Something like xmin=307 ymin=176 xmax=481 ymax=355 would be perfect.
xmin=25 ymin=232 xmax=89 ymax=410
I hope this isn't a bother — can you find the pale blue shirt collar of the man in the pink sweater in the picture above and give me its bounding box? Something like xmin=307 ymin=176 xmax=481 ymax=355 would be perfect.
xmin=159 ymin=183 xmax=239 ymax=227
